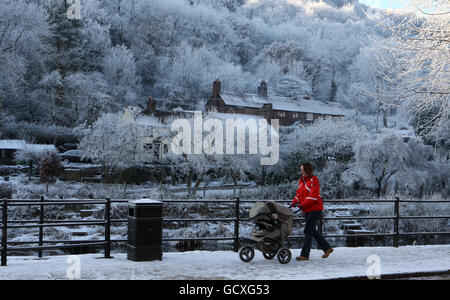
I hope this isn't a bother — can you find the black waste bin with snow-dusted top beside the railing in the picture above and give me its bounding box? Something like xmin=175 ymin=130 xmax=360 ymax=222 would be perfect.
xmin=127 ymin=199 xmax=162 ymax=261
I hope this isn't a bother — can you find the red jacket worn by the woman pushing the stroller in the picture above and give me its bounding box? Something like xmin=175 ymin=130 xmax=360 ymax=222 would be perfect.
xmin=292 ymin=176 xmax=323 ymax=213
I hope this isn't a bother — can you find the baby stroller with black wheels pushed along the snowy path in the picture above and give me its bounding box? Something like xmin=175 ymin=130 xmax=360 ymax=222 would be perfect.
xmin=239 ymin=201 xmax=294 ymax=264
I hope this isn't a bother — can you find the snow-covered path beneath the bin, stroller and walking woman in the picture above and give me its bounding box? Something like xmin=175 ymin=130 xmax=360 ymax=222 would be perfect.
xmin=0 ymin=245 xmax=450 ymax=280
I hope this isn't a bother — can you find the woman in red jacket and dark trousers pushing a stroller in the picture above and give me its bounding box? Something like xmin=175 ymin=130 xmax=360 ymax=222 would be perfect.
xmin=290 ymin=163 xmax=333 ymax=261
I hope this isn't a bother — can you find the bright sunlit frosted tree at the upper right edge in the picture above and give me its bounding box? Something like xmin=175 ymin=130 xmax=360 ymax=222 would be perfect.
xmin=376 ymin=0 xmax=450 ymax=143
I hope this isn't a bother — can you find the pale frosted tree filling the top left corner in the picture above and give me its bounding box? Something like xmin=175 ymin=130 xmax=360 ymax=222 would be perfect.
xmin=0 ymin=0 xmax=50 ymax=119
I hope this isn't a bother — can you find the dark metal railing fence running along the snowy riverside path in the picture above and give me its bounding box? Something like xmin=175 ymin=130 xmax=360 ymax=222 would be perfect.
xmin=0 ymin=196 xmax=450 ymax=266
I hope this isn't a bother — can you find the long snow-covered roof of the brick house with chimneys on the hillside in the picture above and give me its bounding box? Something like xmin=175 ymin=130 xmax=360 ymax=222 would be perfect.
xmin=220 ymin=91 xmax=349 ymax=116
